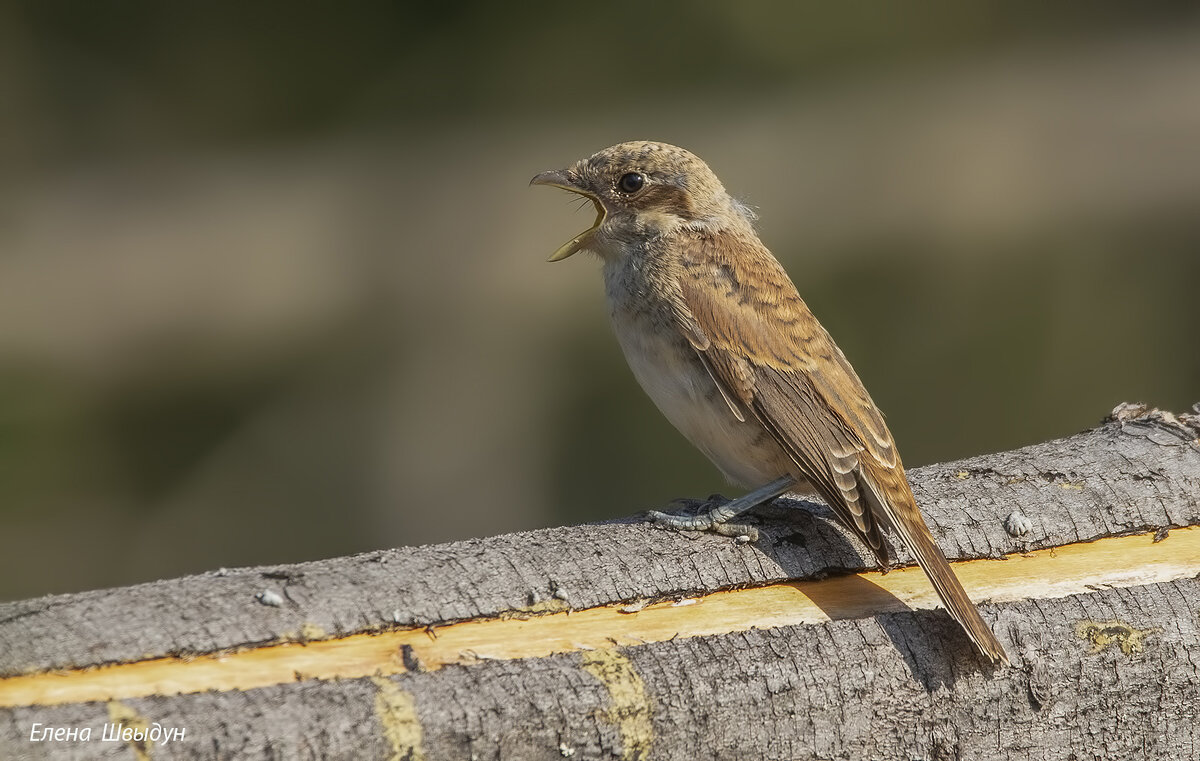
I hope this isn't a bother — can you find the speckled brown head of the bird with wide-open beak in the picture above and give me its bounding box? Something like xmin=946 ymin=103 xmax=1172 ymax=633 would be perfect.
xmin=529 ymin=140 xmax=754 ymax=262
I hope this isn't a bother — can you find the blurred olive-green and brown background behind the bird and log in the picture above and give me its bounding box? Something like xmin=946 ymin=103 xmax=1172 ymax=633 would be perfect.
xmin=0 ymin=0 xmax=1200 ymax=599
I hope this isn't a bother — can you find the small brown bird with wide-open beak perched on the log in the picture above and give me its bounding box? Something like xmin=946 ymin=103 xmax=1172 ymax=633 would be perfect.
xmin=530 ymin=142 xmax=1008 ymax=664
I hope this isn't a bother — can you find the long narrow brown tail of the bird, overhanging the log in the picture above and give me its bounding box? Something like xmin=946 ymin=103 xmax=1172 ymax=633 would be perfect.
xmin=859 ymin=458 xmax=1009 ymax=666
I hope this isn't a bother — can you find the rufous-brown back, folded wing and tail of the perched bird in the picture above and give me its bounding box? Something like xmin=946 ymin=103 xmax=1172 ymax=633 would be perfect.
xmin=676 ymin=233 xmax=1006 ymax=660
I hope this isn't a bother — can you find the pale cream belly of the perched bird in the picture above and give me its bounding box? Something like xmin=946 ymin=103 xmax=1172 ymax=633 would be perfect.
xmin=612 ymin=310 xmax=790 ymax=487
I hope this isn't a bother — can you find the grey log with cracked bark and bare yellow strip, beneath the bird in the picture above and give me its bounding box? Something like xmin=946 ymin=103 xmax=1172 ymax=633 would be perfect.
xmin=0 ymin=406 xmax=1200 ymax=760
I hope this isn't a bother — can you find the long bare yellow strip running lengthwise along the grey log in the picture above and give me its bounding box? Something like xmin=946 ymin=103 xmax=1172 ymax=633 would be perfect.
xmin=0 ymin=526 xmax=1200 ymax=707
